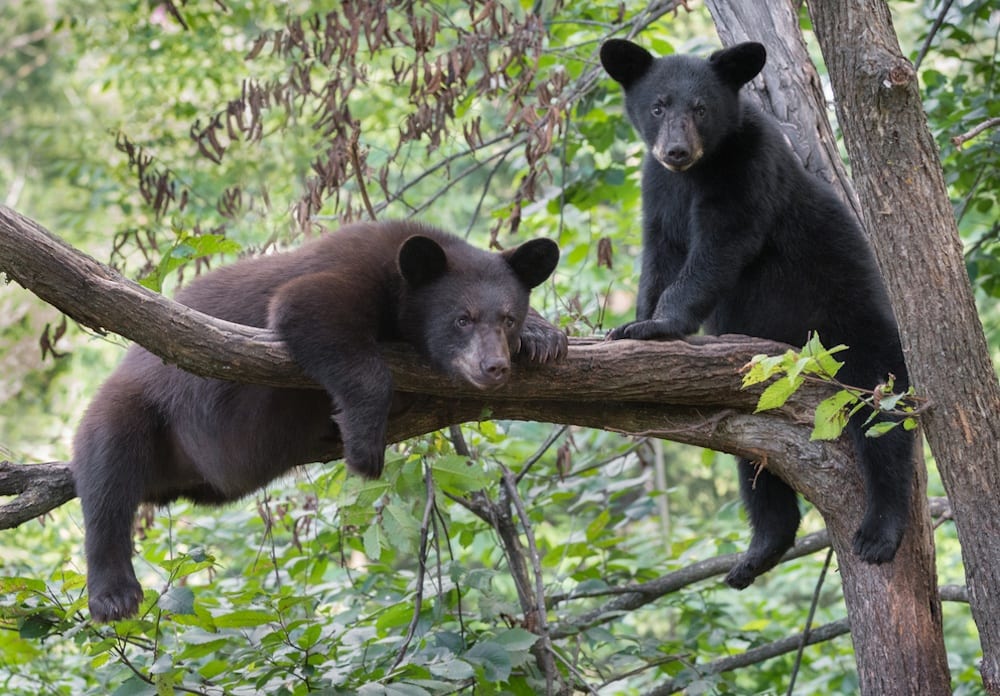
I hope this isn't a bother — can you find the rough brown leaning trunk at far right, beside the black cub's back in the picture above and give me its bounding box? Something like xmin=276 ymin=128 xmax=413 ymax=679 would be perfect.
xmin=809 ymin=0 xmax=1000 ymax=695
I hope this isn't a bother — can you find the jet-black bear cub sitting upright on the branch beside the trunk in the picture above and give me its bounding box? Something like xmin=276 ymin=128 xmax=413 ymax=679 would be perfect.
xmin=601 ymin=39 xmax=914 ymax=588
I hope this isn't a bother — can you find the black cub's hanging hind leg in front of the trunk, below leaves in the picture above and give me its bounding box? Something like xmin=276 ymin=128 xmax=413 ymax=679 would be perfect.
xmin=848 ymin=414 xmax=915 ymax=563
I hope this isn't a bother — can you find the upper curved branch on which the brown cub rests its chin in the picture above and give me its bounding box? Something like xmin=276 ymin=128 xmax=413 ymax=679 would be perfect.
xmin=0 ymin=206 xmax=800 ymax=408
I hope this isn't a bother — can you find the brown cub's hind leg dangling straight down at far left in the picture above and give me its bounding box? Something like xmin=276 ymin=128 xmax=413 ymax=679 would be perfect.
xmin=73 ymin=393 xmax=156 ymax=622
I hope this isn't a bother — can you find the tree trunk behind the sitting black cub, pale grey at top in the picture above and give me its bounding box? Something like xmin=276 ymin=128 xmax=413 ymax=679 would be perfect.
xmin=708 ymin=0 xmax=951 ymax=696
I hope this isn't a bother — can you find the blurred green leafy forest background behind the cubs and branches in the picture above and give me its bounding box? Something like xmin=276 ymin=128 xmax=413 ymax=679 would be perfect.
xmin=0 ymin=0 xmax=1000 ymax=695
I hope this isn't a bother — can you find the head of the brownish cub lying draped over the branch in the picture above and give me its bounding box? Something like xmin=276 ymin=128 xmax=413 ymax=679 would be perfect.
xmin=398 ymin=235 xmax=559 ymax=389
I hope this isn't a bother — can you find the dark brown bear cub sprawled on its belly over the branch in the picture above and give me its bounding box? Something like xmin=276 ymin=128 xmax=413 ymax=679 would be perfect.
xmin=73 ymin=222 xmax=566 ymax=621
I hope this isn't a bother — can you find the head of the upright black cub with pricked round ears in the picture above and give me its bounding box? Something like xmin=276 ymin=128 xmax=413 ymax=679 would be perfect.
xmin=601 ymin=39 xmax=767 ymax=172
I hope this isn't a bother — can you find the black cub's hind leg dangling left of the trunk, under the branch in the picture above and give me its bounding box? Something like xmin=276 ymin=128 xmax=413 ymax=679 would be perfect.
xmin=726 ymin=459 xmax=801 ymax=590
